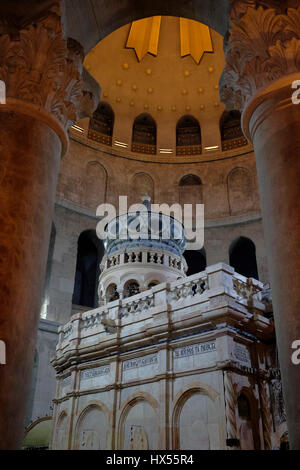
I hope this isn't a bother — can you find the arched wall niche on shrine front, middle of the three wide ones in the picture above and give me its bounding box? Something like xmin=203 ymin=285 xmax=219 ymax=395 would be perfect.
xmin=119 ymin=397 xmax=160 ymax=450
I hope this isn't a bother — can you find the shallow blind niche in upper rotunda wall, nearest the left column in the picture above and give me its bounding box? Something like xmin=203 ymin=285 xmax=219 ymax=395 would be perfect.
xmin=83 ymin=161 xmax=107 ymax=210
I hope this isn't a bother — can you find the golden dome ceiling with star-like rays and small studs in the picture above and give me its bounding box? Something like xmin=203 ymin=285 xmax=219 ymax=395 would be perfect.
xmin=84 ymin=17 xmax=225 ymax=132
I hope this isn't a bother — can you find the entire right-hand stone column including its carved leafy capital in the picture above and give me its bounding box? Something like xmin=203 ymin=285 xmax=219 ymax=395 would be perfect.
xmin=221 ymin=0 xmax=300 ymax=449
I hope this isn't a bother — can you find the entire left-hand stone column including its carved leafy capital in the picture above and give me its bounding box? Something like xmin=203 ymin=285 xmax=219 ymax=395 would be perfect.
xmin=0 ymin=2 xmax=96 ymax=449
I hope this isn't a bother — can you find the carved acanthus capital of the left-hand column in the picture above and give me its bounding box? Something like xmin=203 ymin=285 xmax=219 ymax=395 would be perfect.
xmin=0 ymin=2 xmax=99 ymax=129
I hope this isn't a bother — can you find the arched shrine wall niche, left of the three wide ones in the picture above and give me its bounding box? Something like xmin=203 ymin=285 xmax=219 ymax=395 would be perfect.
xmin=75 ymin=405 xmax=108 ymax=450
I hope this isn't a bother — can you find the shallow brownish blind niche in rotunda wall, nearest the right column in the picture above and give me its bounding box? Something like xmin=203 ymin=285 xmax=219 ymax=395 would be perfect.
xmin=227 ymin=167 xmax=254 ymax=215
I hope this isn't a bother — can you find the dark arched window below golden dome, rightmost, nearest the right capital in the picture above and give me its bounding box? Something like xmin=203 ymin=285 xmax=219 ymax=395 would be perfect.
xmin=220 ymin=111 xmax=248 ymax=151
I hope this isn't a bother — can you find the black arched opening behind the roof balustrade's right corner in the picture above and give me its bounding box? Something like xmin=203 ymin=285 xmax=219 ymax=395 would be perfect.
xmin=229 ymin=237 xmax=258 ymax=279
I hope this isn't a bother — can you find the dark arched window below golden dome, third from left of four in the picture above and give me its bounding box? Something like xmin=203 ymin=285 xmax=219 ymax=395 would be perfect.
xmin=176 ymin=115 xmax=202 ymax=155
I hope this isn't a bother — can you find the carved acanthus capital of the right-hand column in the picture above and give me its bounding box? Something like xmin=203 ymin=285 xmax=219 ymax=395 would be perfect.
xmin=220 ymin=0 xmax=300 ymax=111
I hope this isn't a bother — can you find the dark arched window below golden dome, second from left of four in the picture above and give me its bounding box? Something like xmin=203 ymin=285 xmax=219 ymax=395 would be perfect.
xmin=131 ymin=113 xmax=156 ymax=155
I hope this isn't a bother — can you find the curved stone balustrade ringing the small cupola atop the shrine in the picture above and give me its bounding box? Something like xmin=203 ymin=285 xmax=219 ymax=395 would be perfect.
xmin=101 ymin=248 xmax=187 ymax=273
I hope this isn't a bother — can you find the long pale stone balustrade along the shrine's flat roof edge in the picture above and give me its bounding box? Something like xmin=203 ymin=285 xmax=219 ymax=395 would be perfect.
xmin=58 ymin=263 xmax=266 ymax=350
